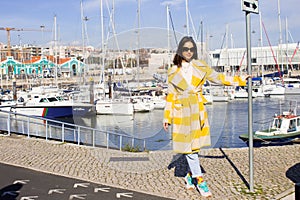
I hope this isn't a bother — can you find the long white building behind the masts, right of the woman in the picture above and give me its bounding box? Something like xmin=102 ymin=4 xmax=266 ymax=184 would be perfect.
xmin=208 ymin=43 xmax=300 ymax=75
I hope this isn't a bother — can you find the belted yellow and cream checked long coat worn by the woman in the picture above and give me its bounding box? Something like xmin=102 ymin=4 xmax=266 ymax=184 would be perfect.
xmin=164 ymin=60 xmax=246 ymax=153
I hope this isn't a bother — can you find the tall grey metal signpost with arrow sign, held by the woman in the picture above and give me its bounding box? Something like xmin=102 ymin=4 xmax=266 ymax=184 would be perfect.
xmin=241 ymin=0 xmax=258 ymax=192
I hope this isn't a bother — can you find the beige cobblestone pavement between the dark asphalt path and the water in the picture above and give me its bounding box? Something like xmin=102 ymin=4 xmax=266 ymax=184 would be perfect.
xmin=0 ymin=135 xmax=300 ymax=200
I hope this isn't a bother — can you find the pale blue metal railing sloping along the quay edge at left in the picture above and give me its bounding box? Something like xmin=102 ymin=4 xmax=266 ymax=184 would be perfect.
xmin=0 ymin=110 xmax=146 ymax=151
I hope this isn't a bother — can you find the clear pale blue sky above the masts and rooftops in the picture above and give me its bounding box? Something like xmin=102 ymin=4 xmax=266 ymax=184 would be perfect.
xmin=0 ymin=0 xmax=300 ymax=50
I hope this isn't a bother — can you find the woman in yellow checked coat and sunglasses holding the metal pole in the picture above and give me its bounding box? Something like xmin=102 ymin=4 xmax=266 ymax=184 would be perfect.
xmin=163 ymin=37 xmax=246 ymax=197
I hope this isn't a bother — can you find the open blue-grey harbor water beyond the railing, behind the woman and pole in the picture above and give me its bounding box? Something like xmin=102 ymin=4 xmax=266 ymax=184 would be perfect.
xmin=67 ymin=95 xmax=300 ymax=150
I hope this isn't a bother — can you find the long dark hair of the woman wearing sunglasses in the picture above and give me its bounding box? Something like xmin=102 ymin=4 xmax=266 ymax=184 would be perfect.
xmin=173 ymin=36 xmax=198 ymax=67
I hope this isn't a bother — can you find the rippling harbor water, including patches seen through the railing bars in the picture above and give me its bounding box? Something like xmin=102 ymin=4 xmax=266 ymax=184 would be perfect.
xmin=4 ymin=95 xmax=300 ymax=151
